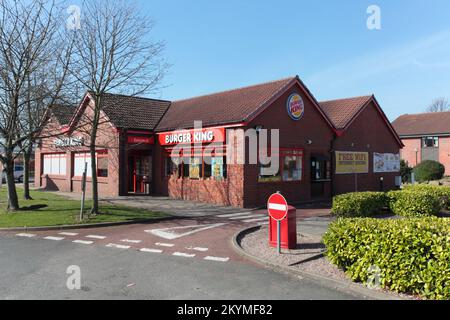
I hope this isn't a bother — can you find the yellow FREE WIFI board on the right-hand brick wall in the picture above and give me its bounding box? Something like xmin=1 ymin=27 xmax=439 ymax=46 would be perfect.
xmin=336 ymin=151 xmax=369 ymax=174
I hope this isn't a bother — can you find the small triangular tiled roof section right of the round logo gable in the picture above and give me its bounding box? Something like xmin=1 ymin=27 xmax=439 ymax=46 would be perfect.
xmin=319 ymin=96 xmax=373 ymax=130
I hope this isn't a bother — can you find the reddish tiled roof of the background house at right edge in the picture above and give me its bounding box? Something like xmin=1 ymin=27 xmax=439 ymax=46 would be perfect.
xmin=392 ymin=112 xmax=450 ymax=137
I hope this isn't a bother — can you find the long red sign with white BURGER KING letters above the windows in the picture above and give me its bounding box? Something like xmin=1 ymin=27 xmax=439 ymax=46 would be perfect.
xmin=158 ymin=128 xmax=225 ymax=146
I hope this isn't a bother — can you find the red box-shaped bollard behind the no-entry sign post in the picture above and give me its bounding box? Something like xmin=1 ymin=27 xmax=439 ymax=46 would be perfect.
xmin=269 ymin=206 xmax=297 ymax=249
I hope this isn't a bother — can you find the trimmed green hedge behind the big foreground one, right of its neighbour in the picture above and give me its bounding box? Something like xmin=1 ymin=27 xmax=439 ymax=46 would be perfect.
xmin=388 ymin=190 xmax=442 ymax=217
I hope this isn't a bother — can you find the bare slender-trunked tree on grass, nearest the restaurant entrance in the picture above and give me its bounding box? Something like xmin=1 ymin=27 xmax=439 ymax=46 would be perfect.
xmin=71 ymin=0 xmax=167 ymax=214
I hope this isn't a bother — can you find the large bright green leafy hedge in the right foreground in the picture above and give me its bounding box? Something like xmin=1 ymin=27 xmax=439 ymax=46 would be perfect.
xmin=323 ymin=218 xmax=450 ymax=299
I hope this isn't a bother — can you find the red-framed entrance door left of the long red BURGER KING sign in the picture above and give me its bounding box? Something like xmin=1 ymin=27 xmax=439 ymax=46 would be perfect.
xmin=128 ymin=153 xmax=151 ymax=194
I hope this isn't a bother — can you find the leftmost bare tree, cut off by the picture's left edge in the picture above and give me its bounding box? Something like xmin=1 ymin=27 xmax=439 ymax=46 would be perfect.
xmin=0 ymin=0 xmax=72 ymax=211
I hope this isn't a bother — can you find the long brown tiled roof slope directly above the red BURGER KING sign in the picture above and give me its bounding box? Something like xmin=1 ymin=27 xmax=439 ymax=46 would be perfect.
xmin=157 ymin=77 xmax=297 ymax=131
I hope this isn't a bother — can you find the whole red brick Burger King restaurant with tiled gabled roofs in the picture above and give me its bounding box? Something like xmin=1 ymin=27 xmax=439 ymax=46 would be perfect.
xmin=36 ymin=77 xmax=402 ymax=207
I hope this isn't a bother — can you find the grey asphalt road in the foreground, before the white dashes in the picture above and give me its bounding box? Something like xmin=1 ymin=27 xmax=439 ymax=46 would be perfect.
xmin=0 ymin=235 xmax=356 ymax=300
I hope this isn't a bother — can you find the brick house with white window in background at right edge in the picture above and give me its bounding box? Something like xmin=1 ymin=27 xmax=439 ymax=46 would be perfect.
xmin=392 ymin=112 xmax=450 ymax=176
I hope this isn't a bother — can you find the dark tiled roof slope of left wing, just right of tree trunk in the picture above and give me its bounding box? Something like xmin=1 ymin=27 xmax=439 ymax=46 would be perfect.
xmin=87 ymin=93 xmax=171 ymax=130
